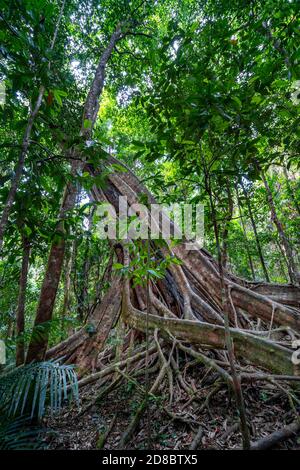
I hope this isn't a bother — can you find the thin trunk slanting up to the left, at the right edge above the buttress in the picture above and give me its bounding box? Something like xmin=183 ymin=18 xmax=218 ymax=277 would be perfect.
xmin=257 ymin=165 xmax=297 ymax=284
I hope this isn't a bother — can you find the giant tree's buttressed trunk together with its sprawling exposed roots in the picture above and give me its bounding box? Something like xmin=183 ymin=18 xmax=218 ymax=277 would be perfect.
xmin=47 ymin=158 xmax=300 ymax=449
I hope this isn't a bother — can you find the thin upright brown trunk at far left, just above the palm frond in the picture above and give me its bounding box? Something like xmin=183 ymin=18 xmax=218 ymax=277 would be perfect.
xmin=16 ymin=238 xmax=30 ymax=366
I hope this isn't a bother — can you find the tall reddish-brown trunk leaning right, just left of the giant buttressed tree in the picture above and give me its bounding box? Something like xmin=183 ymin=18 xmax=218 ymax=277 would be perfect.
xmin=26 ymin=25 xmax=122 ymax=363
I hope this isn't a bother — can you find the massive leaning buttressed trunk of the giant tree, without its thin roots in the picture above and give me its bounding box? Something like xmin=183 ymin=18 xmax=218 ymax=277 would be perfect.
xmin=47 ymin=157 xmax=300 ymax=375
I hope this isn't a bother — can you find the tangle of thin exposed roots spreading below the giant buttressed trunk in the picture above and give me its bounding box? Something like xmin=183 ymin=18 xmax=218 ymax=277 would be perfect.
xmin=47 ymin=332 xmax=299 ymax=449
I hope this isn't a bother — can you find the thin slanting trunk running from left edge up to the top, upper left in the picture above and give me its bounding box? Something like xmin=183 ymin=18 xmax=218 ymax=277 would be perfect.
xmin=0 ymin=0 xmax=65 ymax=253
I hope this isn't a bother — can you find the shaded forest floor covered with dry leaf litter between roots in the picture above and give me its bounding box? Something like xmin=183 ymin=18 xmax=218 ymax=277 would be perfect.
xmin=46 ymin=375 xmax=300 ymax=450
